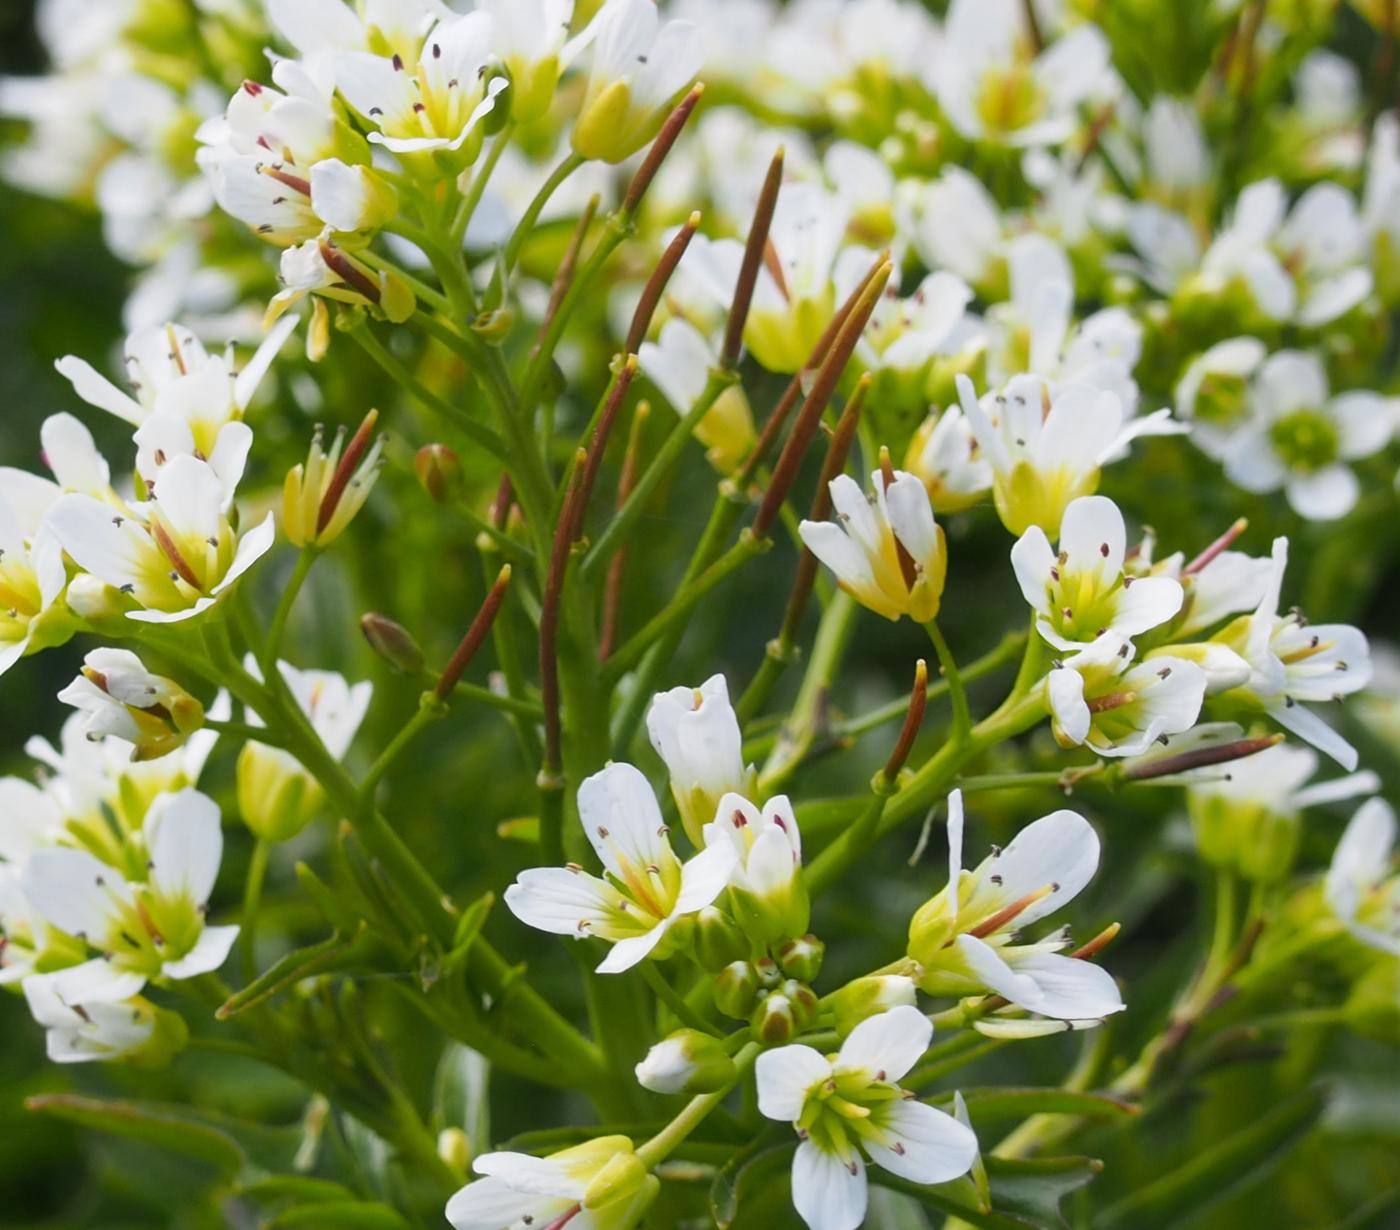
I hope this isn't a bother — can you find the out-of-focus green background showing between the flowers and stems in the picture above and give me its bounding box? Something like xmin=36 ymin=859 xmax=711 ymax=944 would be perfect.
xmin=0 ymin=0 xmax=1400 ymax=1230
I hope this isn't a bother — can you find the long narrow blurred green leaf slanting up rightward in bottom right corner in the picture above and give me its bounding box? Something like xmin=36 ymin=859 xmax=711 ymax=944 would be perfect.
xmin=1093 ymin=1089 xmax=1327 ymax=1230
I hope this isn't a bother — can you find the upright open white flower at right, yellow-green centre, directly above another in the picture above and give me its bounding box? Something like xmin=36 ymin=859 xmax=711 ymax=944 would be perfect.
xmin=1011 ymin=495 xmax=1182 ymax=649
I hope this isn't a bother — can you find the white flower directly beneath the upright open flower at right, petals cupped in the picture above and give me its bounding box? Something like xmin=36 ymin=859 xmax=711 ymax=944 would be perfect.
xmin=1044 ymin=632 xmax=1205 ymax=756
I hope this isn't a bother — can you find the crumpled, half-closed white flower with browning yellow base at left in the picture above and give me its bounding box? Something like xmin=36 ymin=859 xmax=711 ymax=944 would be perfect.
xmin=59 ymin=648 xmax=204 ymax=760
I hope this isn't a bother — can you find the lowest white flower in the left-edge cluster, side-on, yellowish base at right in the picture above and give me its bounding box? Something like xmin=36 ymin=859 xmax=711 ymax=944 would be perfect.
xmin=24 ymin=961 xmax=157 ymax=1063
